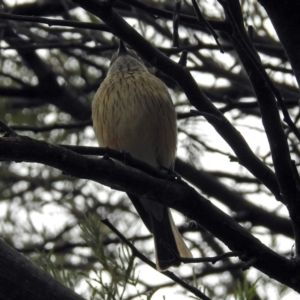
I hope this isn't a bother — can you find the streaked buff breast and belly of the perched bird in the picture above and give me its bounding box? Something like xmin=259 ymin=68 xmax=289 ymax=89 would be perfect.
xmin=93 ymin=71 xmax=177 ymax=167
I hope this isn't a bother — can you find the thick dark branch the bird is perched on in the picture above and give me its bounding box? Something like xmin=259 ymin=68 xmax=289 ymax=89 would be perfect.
xmin=0 ymin=137 xmax=300 ymax=292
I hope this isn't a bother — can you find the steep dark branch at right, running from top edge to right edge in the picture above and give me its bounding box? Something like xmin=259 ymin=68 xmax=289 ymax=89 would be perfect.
xmin=219 ymin=0 xmax=300 ymax=256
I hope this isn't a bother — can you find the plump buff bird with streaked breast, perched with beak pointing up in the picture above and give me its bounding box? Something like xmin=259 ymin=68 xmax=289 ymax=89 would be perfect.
xmin=92 ymin=40 xmax=192 ymax=271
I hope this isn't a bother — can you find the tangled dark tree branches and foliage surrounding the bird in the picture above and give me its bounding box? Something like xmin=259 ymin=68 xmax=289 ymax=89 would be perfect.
xmin=0 ymin=0 xmax=300 ymax=300
